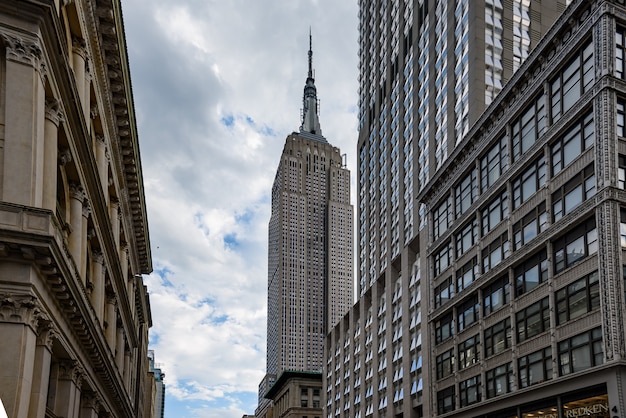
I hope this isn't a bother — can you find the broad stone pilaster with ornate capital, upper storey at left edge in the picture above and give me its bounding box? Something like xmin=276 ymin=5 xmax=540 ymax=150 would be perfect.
xmin=0 ymin=33 xmax=45 ymax=207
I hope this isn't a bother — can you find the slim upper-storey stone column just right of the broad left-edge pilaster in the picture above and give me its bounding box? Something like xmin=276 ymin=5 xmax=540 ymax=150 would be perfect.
xmin=42 ymin=99 xmax=63 ymax=213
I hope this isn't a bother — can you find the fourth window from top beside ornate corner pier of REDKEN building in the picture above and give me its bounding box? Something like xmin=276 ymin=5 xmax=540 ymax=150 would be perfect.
xmin=552 ymin=218 xmax=598 ymax=273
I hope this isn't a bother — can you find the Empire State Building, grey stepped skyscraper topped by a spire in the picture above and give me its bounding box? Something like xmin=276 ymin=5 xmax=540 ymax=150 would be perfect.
xmin=256 ymin=37 xmax=354 ymax=416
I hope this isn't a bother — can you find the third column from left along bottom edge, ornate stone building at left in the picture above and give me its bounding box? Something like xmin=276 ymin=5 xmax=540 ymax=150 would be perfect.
xmin=54 ymin=360 xmax=83 ymax=418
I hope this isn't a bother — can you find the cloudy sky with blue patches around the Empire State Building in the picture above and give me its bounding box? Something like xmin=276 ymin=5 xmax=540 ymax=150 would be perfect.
xmin=122 ymin=0 xmax=358 ymax=418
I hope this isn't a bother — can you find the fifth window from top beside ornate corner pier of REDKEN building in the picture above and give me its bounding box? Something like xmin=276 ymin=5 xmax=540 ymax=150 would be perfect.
xmin=556 ymin=271 xmax=600 ymax=324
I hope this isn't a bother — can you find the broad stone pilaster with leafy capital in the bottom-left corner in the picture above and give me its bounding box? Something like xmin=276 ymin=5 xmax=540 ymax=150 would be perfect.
xmin=0 ymin=294 xmax=38 ymax=417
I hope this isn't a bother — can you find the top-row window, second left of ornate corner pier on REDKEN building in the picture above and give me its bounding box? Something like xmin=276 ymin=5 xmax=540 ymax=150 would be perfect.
xmin=511 ymin=94 xmax=546 ymax=161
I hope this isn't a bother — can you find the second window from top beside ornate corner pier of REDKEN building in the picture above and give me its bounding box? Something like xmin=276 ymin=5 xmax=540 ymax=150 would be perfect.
xmin=551 ymin=113 xmax=594 ymax=176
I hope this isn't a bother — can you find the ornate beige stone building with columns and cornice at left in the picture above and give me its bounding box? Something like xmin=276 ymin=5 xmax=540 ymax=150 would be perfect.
xmin=0 ymin=0 xmax=152 ymax=418
